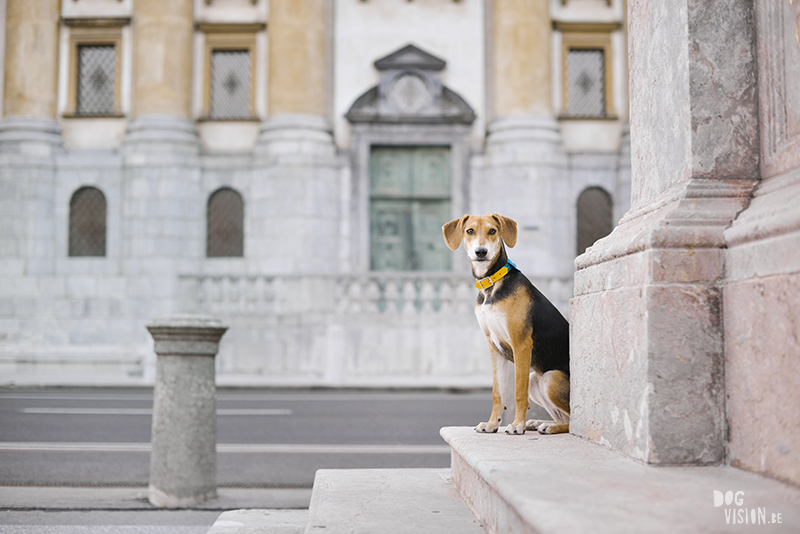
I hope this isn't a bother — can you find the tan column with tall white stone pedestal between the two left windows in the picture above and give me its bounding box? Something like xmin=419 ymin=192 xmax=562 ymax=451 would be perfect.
xmin=121 ymin=0 xmax=203 ymax=336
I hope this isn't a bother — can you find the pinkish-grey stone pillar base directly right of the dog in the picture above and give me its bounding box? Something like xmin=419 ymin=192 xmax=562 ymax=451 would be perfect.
xmin=570 ymin=179 xmax=755 ymax=464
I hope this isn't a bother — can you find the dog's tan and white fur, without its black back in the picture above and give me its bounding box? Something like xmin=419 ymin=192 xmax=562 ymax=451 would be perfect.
xmin=442 ymin=213 xmax=569 ymax=434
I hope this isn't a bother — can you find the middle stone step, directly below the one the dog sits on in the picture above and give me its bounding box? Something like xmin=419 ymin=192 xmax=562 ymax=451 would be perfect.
xmin=305 ymin=469 xmax=485 ymax=534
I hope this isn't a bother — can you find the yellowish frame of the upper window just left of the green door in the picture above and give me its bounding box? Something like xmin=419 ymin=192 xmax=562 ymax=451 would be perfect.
xmin=198 ymin=24 xmax=263 ymax=122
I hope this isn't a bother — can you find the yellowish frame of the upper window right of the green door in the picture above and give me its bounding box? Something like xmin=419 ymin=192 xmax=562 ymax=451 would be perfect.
xmin=556 ymin=23 xmax=618 ymax=120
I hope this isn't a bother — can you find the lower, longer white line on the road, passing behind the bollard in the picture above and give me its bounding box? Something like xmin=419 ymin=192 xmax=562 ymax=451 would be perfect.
xmin=0 ymin=442 xmax=450 ymax=454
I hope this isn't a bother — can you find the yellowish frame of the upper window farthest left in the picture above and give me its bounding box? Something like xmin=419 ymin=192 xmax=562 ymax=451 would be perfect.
xmin=62 ymin=21 xmax=126 ymax=119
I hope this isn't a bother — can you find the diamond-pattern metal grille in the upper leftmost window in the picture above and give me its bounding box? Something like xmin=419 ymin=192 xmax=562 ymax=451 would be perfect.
xmin=76 ymin=45 xmax=117 ymax=116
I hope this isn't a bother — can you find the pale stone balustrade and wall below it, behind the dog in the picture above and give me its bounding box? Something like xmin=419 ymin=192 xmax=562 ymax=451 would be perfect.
xmin=179 ymin=273 xmax=572 ymax=387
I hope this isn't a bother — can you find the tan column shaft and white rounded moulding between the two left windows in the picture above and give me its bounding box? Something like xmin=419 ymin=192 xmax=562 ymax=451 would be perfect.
xmin=125 ymin=0 xmax=200 ymax=153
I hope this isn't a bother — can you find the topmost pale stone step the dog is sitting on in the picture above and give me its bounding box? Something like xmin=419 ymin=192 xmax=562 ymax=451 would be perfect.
xmin=440 ymin=427 xmax=800 ymax=534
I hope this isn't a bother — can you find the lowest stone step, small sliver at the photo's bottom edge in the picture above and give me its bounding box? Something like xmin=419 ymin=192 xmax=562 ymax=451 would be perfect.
xmin=208 ymin=510 xmax=308 ymax=534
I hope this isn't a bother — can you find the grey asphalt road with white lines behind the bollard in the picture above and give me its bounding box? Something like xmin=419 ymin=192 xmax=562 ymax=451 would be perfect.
xmin=0 ymin=388 xmax=536 ymax=488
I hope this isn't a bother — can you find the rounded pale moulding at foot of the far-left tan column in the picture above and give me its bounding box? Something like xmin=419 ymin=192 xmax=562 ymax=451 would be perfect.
xmin=0 ymin=115 xmax=64 ymax=157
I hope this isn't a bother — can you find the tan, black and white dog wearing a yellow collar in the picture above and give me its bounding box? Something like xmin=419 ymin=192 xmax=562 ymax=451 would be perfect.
xmin=442 ymin=213 xmax=569 ymax=434
